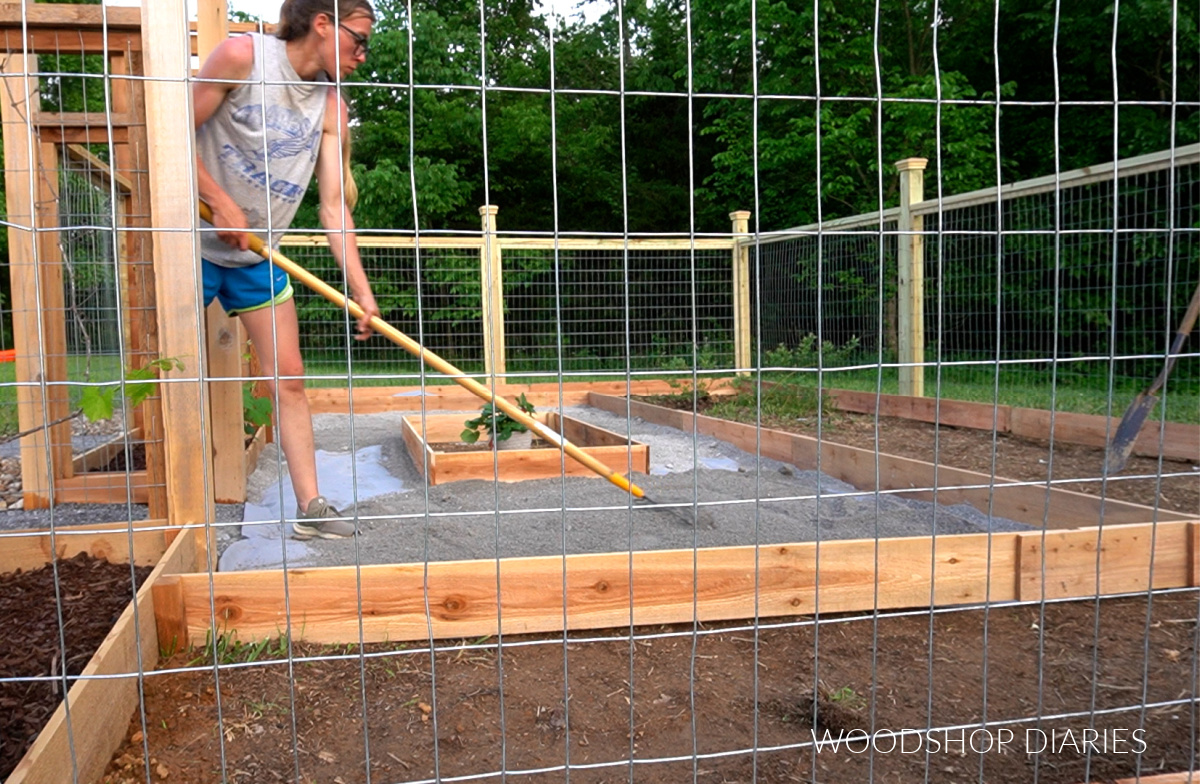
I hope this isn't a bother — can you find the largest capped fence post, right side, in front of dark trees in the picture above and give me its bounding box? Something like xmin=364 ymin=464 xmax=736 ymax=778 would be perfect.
xmin=896 ymin=158 xmax=929 ymax=397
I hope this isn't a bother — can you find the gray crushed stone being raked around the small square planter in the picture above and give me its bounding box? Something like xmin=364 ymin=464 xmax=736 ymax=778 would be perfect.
xmin=221 ymin=407 xmax=1031 ymax=569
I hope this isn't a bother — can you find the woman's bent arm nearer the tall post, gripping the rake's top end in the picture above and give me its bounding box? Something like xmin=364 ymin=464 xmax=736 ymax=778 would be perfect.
xmin=192 ymin=35 xmax=254 ymax=251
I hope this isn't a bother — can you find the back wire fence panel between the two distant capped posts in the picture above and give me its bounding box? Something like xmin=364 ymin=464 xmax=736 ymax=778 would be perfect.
xmin=504 ymin=247 xmax=733 ymax=373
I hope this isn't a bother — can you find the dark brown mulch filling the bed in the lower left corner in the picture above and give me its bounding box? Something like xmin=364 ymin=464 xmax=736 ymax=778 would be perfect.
xmin=0 ymin=545 xmax=151 ymax=779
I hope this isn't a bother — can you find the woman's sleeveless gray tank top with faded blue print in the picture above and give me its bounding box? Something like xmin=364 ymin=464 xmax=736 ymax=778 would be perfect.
xmin=196 ymin=32 xmax=330 ymax=267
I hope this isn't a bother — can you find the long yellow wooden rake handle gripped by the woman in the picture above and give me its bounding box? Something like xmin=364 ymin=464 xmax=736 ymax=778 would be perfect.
xmin=199 ymin=202 xmax=646 ymax=498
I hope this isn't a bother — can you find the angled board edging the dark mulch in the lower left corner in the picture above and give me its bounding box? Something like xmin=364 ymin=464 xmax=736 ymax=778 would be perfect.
xmin=6 ymin=523 xmax=196 ymax=784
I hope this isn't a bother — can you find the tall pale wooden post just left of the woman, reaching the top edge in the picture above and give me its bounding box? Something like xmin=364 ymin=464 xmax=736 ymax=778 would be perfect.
xmin=142 ymin=0 xmax=214 ymax=549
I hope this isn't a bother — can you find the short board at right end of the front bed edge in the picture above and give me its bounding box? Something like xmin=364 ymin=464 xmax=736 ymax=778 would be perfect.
xmin=1019 ymin=522 xmax=1195 ymax=602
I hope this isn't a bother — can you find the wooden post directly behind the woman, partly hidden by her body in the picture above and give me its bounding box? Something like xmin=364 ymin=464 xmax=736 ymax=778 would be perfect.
xmin=196 ymin=0 xmax=246 ymax=503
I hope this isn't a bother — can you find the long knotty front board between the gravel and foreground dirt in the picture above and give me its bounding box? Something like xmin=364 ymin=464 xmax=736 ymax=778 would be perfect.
xmin=169 ymin=534 xmax=1016 ymax=644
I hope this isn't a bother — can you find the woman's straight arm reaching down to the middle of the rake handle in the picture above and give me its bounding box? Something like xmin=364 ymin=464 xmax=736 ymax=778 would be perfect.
xmin=317 ymin=86 xmax=379 ymax=340
